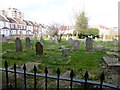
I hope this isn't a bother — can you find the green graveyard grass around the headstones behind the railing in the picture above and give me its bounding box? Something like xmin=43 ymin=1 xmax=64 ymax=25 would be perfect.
xmin=1 ymin=38 xmax=118 ymax=80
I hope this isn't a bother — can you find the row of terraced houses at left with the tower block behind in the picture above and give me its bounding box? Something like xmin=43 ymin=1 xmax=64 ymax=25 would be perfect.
xmin=0 ymin=8 xmax=43 ymax=37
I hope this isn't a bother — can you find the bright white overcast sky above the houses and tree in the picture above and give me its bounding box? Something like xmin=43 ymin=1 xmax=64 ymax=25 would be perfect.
xmin=0 ymin=0 xmax=120 ymax=27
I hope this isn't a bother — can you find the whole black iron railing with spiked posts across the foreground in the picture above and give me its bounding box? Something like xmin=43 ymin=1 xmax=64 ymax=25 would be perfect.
xmin=0 ymin=61 xmax=120 ymax=90
